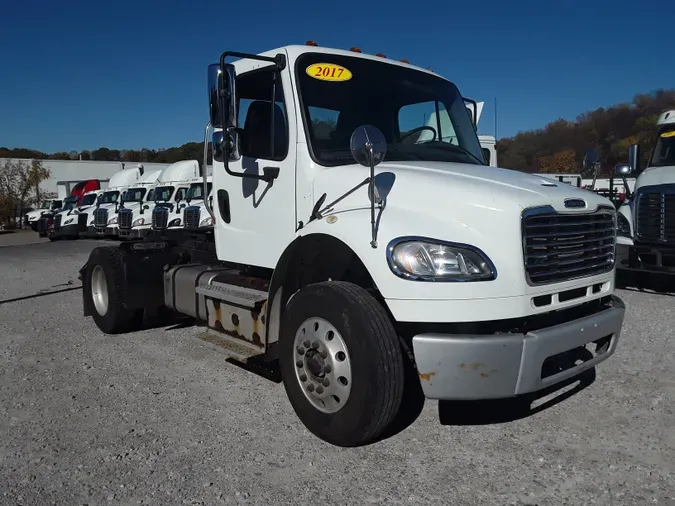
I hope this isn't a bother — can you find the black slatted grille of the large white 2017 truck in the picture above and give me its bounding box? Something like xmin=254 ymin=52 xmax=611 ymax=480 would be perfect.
xmin=522 ymin=208 xmax=616 ymax=285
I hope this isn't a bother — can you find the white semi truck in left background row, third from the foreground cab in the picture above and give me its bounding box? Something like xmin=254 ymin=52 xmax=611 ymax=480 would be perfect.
xmin=112 ymin=170 xmax=162 ymax=239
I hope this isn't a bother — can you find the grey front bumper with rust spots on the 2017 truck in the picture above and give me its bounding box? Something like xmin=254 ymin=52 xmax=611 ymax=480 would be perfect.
xmin=412 ymin=296 xmax=625 ymax=400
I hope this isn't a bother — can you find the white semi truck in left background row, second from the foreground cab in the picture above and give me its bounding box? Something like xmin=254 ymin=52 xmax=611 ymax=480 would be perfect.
xmin=120 ymin=160 xmax=200 ymax=238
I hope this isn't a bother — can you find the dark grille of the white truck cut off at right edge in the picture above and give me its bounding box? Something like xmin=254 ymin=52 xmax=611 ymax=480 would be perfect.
xmin=635 ymin=188 xmax=675 ymax=243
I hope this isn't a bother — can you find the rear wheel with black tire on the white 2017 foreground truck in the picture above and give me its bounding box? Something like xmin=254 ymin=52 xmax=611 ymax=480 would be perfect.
xmin=82 ymin=246 xmax=143 ymax=334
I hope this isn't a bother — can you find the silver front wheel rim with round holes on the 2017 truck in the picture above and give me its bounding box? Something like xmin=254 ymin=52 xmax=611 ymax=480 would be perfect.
xmin=293 ymin=318 xmax=352 ymax=414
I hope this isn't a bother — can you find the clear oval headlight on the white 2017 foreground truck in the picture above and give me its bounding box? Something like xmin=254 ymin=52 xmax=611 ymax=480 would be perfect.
xmin=387 ymin=238 xmax=497 ymax=281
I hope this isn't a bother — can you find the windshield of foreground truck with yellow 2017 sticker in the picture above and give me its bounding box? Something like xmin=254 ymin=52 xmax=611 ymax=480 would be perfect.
xmin=296 ymin=53 xmax=485 ymax=166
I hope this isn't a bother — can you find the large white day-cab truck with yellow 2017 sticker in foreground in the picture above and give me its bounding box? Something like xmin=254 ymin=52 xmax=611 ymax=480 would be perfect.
xmin=80 ymin=46 xmax=625 ymax=446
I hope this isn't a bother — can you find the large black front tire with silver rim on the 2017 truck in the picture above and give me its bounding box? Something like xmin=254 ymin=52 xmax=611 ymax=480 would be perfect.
xmin=279 ymin=281 xmax=405 ymax=447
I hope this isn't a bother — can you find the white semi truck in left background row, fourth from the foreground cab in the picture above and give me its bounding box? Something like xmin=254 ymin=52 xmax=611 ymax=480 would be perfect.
xmin=81 ymin=165 xmax=144 ymax=238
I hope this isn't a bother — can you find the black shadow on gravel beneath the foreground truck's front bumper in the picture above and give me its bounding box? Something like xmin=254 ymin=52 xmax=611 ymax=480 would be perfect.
xmin=438 ymin=367 xmax=596 ymax=425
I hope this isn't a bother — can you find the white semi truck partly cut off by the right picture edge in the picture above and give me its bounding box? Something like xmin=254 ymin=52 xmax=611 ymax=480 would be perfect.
xmin=614 ymin=110 xmax=675 ymax=291
